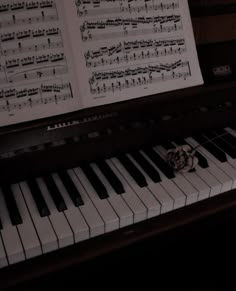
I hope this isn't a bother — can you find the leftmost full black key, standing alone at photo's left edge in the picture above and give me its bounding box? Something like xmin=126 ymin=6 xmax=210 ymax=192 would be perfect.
xmin=1 ymin=184 xmax=23 ymax=225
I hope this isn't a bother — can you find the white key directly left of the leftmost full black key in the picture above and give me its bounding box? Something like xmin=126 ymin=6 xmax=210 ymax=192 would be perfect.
xmin=0 ymin=190 xmax=25 ymax=264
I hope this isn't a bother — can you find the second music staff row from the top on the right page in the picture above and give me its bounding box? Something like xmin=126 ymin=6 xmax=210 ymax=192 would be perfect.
xmin=80 ymin=14 xmax=183 ymax=41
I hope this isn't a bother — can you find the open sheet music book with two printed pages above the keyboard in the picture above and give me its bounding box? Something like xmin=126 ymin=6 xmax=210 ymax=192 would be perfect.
xmin=0 ymin=0 xmax=203 ymax=126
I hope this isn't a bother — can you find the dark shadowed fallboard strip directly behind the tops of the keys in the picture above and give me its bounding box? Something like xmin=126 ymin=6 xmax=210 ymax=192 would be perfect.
xmin=0 ymin=101 xmax=235 ymax=183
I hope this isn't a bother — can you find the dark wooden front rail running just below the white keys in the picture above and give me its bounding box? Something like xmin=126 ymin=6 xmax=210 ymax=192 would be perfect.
xmin=0 ymin=190 xmax=236 ymax=290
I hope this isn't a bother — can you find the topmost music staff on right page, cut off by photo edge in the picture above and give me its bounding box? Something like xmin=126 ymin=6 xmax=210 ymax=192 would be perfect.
xmin=75 ymin=0 xmax=179 ymax=17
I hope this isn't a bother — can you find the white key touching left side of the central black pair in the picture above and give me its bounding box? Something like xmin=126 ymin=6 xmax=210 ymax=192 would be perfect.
xmin=75 ymin=168 xmax=119 ymax=232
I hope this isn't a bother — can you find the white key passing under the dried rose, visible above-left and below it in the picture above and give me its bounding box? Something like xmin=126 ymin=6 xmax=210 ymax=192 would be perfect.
xmin=154 ymin=146 xmax=199 ymax=205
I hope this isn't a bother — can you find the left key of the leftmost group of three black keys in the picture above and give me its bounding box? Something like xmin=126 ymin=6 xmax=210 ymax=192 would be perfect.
xmin=27 ymin=179 xmax=51 ymax=217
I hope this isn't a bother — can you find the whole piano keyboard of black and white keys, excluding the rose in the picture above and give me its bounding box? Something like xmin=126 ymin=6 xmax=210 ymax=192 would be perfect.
xmin=0 ymin=128 xmax=236 ymax=268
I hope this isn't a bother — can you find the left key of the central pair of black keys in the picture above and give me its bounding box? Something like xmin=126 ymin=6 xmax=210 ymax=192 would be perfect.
xmin=80 ymin=164 xmax=109 ymax=199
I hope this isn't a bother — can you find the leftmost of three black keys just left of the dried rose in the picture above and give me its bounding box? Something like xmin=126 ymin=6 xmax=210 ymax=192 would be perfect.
xmin=117 ymin=154 xmax=148 ymax=187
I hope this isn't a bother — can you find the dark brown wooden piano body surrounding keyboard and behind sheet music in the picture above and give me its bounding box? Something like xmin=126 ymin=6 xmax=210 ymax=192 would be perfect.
xmin=0 ymin=0 xmax=236 ymax=289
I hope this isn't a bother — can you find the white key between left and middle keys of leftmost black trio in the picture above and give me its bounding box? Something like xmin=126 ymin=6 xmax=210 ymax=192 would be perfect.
xmin=36 ymin=178 xmax=74 ymax=248
